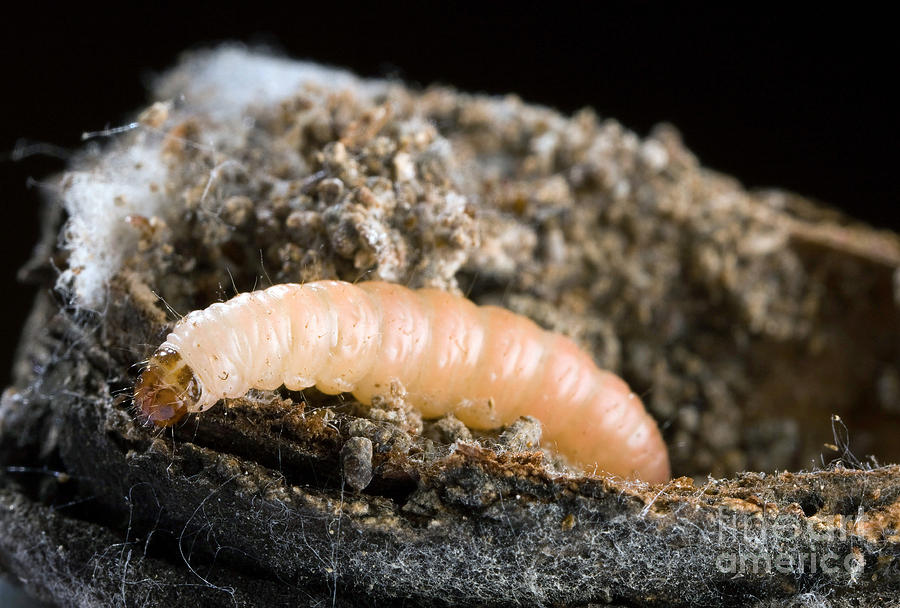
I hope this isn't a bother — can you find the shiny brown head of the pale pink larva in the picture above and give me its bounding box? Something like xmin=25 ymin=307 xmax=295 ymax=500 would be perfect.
xmin=134 ymin=348 xmax=200 ymax=426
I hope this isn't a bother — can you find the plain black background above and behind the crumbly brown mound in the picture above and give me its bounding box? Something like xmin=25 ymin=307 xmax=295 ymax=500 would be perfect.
xmin=0 ymin=2 xmax=900 ymax=386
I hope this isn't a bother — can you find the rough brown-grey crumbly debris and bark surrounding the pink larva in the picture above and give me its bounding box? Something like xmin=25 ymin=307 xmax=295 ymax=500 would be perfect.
xmin=0 ymin=50 xmax=900 ymax=606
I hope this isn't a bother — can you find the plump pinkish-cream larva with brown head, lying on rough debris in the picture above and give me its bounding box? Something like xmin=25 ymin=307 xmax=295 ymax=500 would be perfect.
xmin=134 ymin=281 xmax=669 ymax=482
